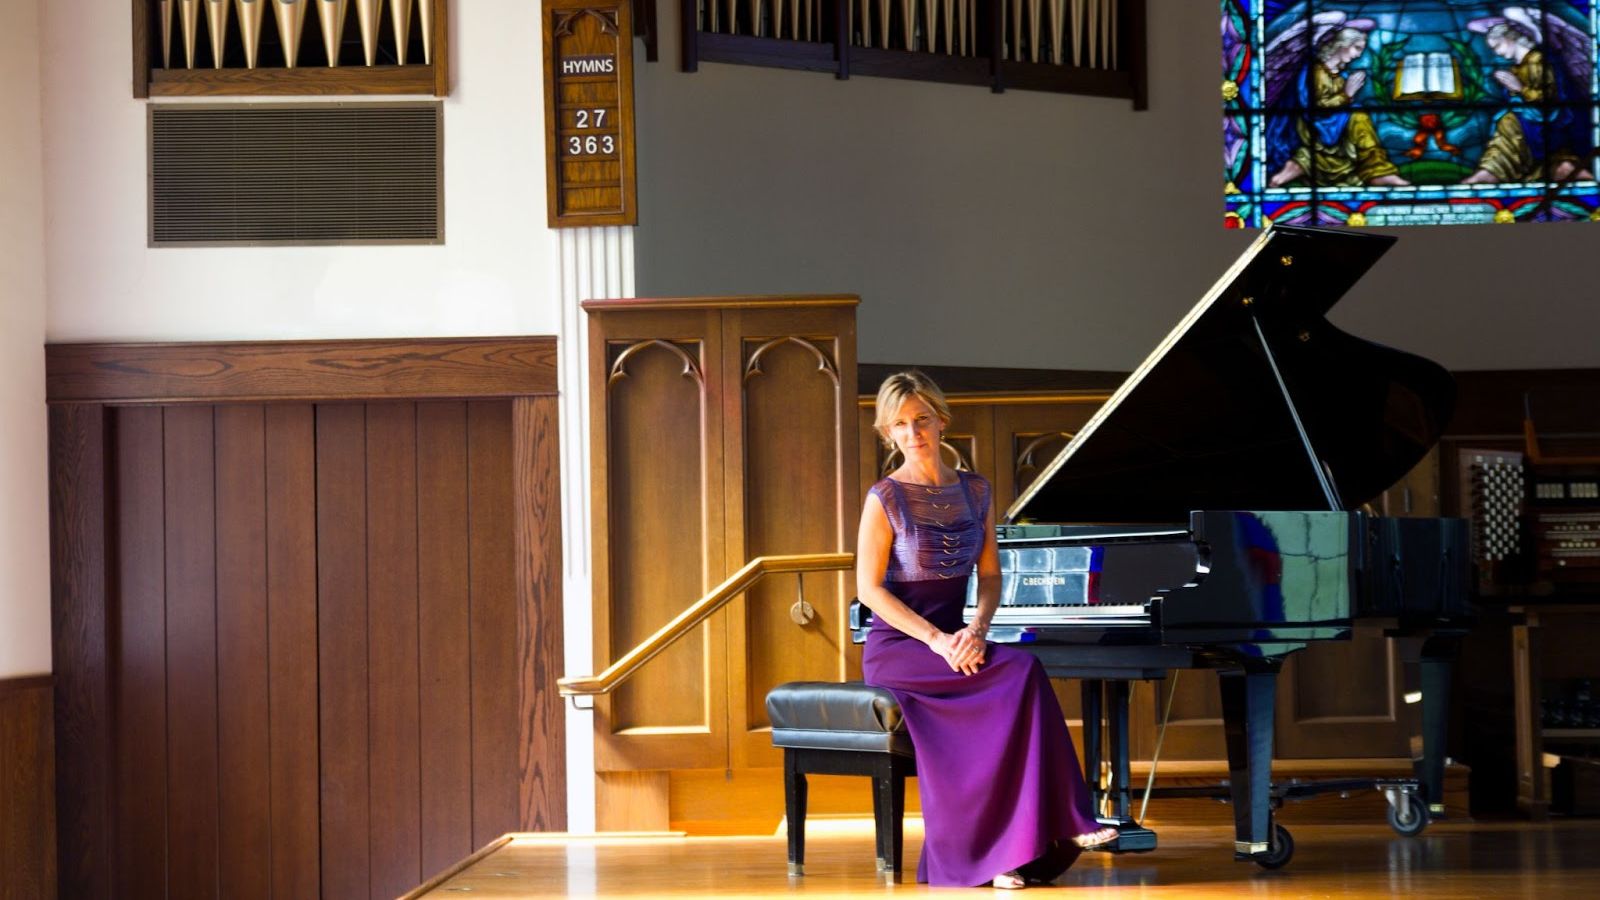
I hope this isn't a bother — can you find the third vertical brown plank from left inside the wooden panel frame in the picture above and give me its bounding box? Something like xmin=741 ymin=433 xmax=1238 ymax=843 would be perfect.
xmin=214 ymin=405 xmax=272 ymax=897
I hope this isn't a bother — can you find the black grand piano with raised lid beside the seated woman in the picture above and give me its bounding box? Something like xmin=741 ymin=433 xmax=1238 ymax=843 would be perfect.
xmin=851 ymin=226 xmax=1470 ymax=868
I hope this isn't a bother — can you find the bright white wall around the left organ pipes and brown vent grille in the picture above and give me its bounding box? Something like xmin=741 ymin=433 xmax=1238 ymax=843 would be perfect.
xmin=40 ymin=0 xmax=560 ymax=341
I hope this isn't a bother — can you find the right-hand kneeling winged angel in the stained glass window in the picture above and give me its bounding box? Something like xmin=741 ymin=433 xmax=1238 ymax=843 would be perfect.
xmin=1462 ymin=6 xmax=1594 ymax=184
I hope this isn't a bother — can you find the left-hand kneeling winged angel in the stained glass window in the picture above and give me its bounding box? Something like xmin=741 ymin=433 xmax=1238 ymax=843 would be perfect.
xmin=1266 ymin=11 xmax=1410 ymax=187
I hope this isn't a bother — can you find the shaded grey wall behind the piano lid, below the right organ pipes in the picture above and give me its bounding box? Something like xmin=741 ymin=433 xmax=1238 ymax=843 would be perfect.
xmin=635 ymin=0 xmax=1600 ymax=370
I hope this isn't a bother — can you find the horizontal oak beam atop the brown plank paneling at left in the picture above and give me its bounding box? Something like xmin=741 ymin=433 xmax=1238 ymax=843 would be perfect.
xmin=45 ymin=336 xmax=557 ymax=404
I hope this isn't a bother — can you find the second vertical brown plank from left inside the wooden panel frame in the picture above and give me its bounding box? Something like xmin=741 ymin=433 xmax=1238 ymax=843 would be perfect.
xmin=162 ymin=407 xmax=221 ymax=897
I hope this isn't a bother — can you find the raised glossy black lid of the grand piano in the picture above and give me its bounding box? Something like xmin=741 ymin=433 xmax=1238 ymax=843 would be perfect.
xmin=1005 ymin=226 xmax=1456 ymax=522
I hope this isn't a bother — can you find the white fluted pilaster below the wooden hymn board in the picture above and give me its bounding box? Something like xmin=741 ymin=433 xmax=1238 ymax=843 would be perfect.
xmin=557 ymin=226 xmax=634 ymax=831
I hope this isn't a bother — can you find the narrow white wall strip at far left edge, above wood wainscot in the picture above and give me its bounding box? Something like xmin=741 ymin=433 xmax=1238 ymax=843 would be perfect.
xmin=0 ymin=3 xmax=50 ymax=679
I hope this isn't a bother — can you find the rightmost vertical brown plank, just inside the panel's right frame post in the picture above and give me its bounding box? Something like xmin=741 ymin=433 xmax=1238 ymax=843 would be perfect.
xmin=467 ymin=400 xmax=518 ymax=847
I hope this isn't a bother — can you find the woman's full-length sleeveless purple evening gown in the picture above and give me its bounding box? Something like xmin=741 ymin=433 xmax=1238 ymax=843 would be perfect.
xmin=861 ymin=472 xmax=1099 ymax=887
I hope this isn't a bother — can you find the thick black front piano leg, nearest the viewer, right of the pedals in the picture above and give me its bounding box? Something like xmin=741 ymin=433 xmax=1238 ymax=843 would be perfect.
xmin=1219 ymin=669 xmax=1278 ymax=860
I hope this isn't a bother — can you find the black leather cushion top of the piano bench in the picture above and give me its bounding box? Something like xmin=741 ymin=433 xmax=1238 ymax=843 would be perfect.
xmin=766 ymin=681 xmax=912 ymax=756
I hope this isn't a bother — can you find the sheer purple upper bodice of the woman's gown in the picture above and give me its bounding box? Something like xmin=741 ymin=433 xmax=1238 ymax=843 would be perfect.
xmin=872 ymin=472 xmax=989 ymax=585
